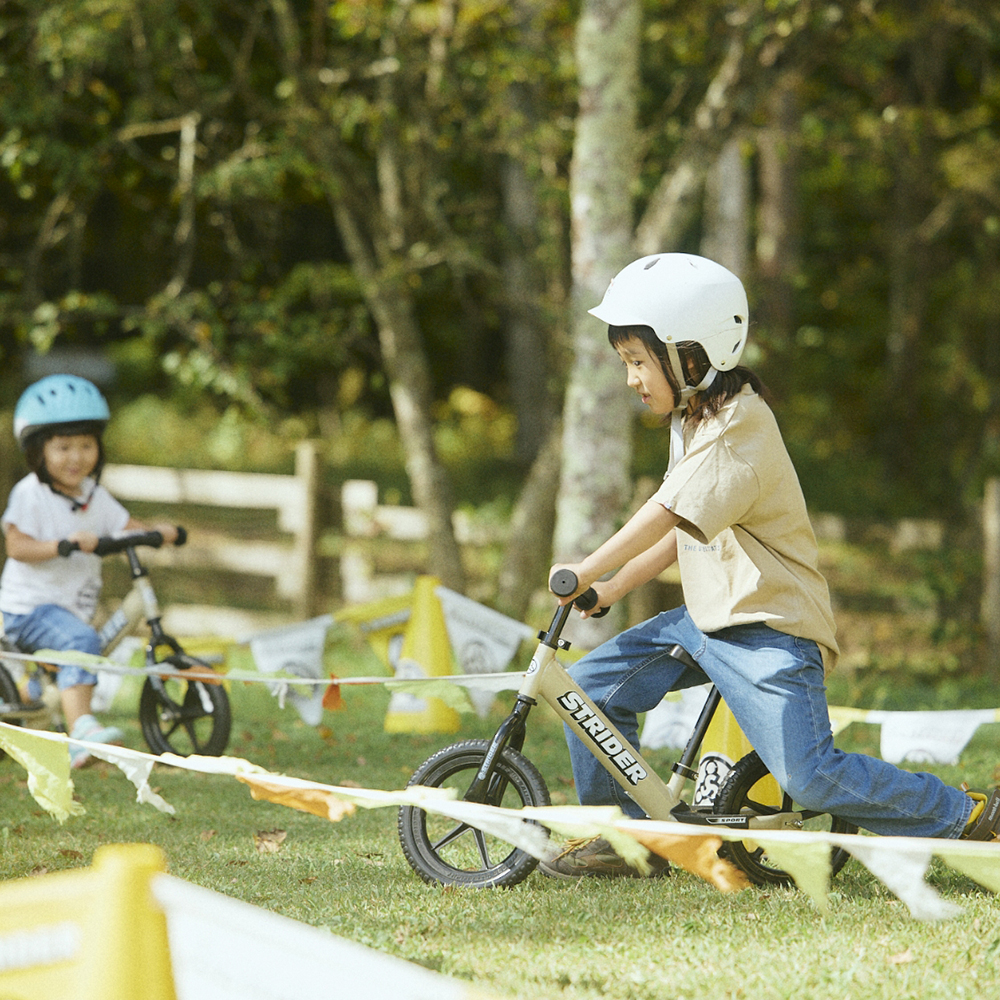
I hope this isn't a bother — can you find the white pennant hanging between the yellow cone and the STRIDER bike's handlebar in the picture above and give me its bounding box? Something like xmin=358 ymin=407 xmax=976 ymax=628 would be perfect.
xmin=434 ymin=587 xmax=537 ymax=718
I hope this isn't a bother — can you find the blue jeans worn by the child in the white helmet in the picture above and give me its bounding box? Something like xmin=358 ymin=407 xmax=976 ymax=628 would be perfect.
xmin=567 ymin=607 xmax=973 ymax=837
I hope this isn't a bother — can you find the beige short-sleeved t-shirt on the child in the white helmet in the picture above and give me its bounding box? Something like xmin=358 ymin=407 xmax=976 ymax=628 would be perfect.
xmin=653 ymin=385 xmax=838 ymax=671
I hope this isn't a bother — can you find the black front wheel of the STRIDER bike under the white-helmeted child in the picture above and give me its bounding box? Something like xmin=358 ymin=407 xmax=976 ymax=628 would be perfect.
xmin=398 ymin=740 xmax=549 ymax=889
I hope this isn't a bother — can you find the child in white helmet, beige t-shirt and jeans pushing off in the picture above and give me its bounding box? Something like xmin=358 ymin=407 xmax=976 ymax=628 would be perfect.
xmin=541 ymin=253 xmax=1000 ymax=878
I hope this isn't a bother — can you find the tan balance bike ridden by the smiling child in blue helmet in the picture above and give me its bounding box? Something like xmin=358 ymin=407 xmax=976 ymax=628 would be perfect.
xmin=0 ymin=528 xmax=232 ymax=757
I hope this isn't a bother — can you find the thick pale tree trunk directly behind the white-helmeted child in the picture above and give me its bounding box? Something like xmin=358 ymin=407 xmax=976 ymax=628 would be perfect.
xmin=555 ymin=0 xmax=641 ymax=634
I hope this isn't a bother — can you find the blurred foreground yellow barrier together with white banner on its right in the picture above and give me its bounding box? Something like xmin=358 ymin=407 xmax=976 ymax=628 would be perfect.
xmin=0 ymin=844 xmax=500 ymax=1000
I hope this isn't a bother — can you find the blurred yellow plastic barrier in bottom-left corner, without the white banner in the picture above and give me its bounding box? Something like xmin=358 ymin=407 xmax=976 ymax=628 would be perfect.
xmin=0 ymin=844 xmax=176 ymax=1000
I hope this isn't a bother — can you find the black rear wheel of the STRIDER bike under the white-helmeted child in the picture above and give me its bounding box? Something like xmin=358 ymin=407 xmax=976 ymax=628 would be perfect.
xmin=712 ymin=752 xmax=858 ymax=885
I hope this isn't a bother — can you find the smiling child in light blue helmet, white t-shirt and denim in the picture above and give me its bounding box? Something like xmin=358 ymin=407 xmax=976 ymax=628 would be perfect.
xmin=0 ymin=375 xmax=177 ymax=767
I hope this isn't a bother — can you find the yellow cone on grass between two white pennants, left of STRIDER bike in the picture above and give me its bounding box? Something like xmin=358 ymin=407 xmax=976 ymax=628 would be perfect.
xmin=385 ymin=576 xmax=459 ymax=733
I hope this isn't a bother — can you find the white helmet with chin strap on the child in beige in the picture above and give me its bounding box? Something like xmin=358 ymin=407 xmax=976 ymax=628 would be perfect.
xmin=590 ymin=253 xmax=750 ymax=404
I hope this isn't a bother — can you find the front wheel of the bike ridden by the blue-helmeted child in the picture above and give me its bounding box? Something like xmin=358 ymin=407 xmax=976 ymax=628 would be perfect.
xmin=139 ymin=677 xmax=232 ymax=757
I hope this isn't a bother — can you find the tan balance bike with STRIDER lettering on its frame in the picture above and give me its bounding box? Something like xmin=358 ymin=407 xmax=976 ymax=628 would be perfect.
xmin=398 ymin=570 xmax=857 ymax=888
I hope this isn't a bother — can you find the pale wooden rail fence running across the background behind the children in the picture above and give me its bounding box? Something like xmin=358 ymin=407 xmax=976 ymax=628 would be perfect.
xmin=95 ymin=456 xmax=1000 ymax=644
